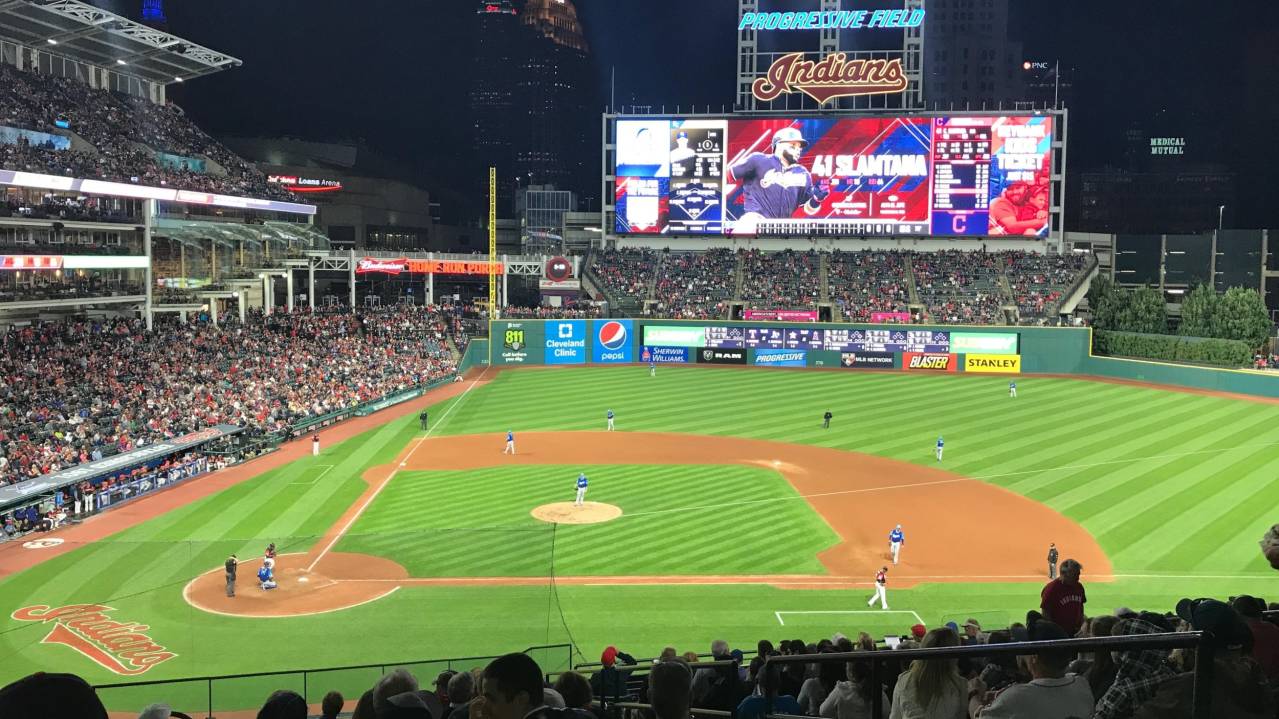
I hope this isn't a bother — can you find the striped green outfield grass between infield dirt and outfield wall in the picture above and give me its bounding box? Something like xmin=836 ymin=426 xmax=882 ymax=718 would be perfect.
xmin=427 ymin=366 xmax=1279 ymax=574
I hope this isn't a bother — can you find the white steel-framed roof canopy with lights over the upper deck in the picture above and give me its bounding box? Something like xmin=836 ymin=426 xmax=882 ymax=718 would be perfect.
xmin=0 ymin=0 xmax=242 ymax=84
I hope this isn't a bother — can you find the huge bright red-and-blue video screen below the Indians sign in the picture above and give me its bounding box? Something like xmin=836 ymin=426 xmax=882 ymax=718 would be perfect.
xmin=614 ymin=115 xmax=1053 ymax=237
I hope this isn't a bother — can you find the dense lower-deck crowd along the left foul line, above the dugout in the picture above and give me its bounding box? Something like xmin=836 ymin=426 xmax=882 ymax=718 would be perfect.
xmin=0 ymin=306 xmax=457 ymax=484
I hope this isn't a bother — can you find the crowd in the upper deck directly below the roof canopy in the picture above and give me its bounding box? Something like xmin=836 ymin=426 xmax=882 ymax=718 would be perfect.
xmin=0 ymin=63 xmax=293 ymax=201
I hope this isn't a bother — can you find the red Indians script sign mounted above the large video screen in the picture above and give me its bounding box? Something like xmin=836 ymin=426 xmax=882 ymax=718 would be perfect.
xmin=751 ymin=52 xmax=907 ymax=104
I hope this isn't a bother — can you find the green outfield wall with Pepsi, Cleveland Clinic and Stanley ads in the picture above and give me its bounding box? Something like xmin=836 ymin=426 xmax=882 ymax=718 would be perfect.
xmin=491 ymin=320 xmax=1279 ymax=397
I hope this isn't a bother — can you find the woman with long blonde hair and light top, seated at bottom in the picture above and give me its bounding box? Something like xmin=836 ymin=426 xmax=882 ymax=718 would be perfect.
xmin=889 ymin=627 xmax=968 ymax=719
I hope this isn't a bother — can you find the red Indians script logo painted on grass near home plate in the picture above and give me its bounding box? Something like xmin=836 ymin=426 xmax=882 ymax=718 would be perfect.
xmin=12 ymin=604 xmax=178 ymax=677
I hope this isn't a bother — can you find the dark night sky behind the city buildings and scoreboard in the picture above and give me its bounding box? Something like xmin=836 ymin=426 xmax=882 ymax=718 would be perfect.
xmin=100 ymin=0 xmax=1279 ymax=226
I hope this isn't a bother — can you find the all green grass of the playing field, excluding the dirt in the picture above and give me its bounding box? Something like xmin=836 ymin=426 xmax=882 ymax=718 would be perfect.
xmin=0 ymin=366 xmax=1279 ymax=710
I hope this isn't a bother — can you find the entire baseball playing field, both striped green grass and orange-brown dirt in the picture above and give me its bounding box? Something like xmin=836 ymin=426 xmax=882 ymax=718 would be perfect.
xmin=0 ymin=365 xmax=1279 ymax=706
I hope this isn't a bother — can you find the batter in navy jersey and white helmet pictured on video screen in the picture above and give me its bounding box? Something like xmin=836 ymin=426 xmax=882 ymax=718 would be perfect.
xmin=729 ymin=128 xmax=830 ymax=234
